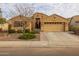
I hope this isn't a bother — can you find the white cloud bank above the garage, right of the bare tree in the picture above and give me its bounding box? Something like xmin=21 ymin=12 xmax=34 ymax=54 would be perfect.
xmin=34 ymin=3 xmax=79 ymax=18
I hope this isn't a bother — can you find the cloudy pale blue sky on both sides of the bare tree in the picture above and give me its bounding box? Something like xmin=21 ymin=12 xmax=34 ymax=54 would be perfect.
xmin=0 ymin=3 xmax=79 ymax=18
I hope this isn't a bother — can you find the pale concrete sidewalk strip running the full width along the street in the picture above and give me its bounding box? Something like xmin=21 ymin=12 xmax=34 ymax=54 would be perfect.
xmin=0 ymin=41 xmax=79 ymax=48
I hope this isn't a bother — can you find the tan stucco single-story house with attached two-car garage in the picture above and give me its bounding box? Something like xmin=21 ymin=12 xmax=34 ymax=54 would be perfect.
xmin=8 ymin=13 xmax=69 ymax=32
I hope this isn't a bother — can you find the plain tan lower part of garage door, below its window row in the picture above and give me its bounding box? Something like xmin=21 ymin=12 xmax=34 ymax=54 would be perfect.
xmin=42 ymin=24 xmax=64 ymax=32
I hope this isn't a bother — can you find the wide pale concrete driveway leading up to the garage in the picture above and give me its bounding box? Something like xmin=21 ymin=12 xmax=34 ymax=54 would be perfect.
xmin=40 ymin=32 xmax=79 ymax=47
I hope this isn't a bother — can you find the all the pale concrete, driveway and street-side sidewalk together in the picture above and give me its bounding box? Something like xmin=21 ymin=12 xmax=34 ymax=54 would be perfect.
xmin=0 ymin=32 xmax=79 ymax=48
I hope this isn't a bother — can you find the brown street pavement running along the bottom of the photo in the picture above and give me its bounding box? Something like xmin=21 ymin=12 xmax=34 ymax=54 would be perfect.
xmin=0 ymin=48 xmax=79 ymax=56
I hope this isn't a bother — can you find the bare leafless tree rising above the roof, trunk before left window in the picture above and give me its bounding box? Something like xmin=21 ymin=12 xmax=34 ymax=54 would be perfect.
xmin=14 ymin=4 xmax=35 ymax=33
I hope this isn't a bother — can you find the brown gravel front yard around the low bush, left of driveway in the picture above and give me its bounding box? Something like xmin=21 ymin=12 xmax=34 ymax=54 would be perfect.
xmin=0 ymin=33 xmax=40 ymax=41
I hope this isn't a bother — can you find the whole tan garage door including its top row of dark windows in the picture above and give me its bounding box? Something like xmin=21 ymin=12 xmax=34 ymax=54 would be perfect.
xmin=42 ymin=22 xmax=64 ymax=32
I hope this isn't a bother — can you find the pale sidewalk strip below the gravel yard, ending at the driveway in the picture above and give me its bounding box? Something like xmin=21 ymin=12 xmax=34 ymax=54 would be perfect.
xmin=0 ymin=41 xmax=48 ymax=48
